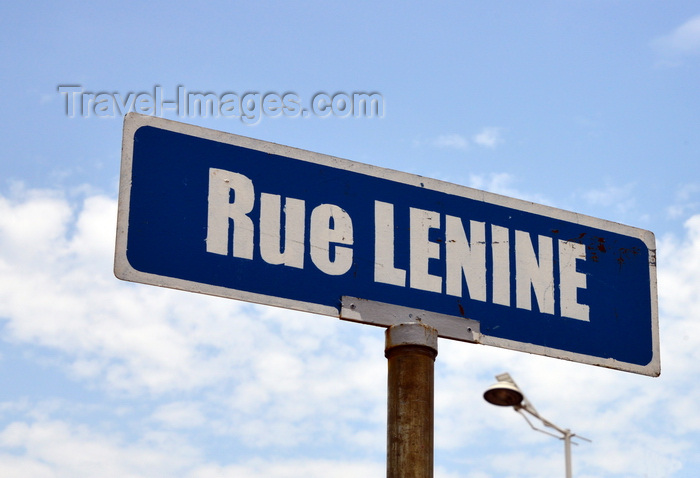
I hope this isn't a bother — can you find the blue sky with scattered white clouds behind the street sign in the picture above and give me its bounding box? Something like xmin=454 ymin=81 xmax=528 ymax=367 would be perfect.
xmin=0 ymin=0 xmax=700 ymax=478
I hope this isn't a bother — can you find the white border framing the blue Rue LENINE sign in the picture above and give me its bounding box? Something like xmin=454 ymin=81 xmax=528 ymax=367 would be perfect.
xmin=114 ymin=113 xmax=661 ymax=376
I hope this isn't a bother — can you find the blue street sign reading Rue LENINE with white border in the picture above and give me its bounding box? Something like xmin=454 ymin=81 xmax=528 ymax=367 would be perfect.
xmin=115 ymin=114 xmax=660 ymax=376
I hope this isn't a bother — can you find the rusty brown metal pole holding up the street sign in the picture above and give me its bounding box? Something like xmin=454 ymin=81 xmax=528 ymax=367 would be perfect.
xmin=384 ymin=322 xmax=437 ymax=478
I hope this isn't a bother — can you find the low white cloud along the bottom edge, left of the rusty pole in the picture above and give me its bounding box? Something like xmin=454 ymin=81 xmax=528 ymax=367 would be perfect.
xmin=0 ymin=414 xmax=384 ymax=478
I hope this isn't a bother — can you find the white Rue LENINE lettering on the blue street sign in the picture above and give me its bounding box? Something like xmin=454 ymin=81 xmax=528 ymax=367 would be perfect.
xmin=206 ymin=168 xmax=589 ymax=321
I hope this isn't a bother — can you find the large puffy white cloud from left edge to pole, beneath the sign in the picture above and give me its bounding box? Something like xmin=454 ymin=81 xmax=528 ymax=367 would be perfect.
xmin=0 ymin=187 xmax=385 ymax=448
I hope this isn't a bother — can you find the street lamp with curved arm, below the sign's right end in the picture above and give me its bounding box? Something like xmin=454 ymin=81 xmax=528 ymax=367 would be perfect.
xmin=484 ymin=373 xmax=591 ymax=478
